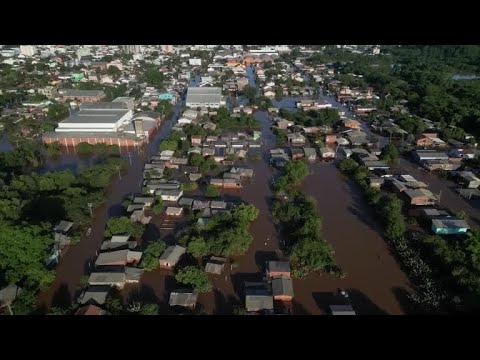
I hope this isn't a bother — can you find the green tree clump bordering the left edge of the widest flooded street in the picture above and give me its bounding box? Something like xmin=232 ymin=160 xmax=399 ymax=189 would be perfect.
xmin=272 ymin=193 xmax=341 ymax=278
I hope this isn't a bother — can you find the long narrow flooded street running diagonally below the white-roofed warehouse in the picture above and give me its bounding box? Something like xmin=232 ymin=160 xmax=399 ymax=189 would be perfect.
xmin=39 ymin=103 xmax=181 ymax=308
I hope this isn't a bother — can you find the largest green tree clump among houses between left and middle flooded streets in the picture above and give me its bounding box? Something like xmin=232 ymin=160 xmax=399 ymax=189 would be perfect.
xmin=180 ymin=204 xmax=259 ymax=257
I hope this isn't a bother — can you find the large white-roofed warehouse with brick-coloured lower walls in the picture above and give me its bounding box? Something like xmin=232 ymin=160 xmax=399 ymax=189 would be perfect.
xmin=43 ymin=102 xmax=160 ymax=147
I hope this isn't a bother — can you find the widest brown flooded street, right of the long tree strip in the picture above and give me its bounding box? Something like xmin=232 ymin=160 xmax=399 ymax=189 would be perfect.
xmin=294 ymin=163 xmax=409 ymax=315
